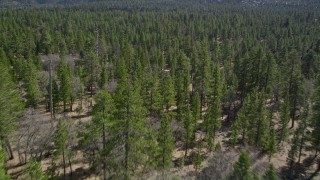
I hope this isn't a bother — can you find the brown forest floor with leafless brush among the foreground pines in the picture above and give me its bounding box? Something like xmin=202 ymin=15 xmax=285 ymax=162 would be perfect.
xmin=7 ymin=97 xmax=317 ymax=179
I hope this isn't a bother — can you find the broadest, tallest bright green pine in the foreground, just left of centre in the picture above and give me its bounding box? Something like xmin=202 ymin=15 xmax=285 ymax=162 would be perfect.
xmin=114 ymin=80 xmax=156 ymax=179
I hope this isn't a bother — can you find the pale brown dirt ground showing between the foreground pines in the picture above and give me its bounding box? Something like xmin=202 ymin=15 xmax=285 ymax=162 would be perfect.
xmin=7 ymin=97 xmax=317 ymax=179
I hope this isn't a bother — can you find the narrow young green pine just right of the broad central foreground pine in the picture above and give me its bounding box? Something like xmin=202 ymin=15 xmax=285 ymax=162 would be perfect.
xmin=158 ymin=114 xmax=175 ymax=170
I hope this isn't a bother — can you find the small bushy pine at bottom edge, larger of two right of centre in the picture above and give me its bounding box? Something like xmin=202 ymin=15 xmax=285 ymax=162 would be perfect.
xmin=233 ymin=152 xmax=251 ymax=180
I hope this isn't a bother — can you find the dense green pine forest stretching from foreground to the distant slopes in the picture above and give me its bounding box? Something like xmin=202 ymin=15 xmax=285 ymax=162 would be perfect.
xmin=0 ymin=2 xmax=320 ymax=179
